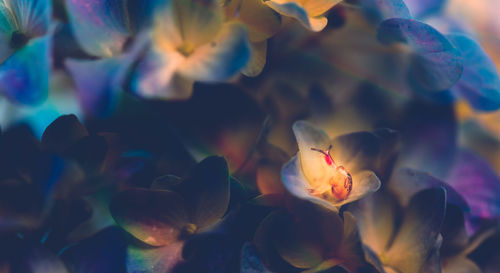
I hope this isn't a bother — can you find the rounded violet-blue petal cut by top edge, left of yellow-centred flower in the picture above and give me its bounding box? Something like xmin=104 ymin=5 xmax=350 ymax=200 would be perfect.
xmin=66 ymin=0 xmax=130 ymax=57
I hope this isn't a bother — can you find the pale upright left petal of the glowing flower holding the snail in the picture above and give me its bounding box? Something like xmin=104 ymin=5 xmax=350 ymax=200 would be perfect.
xmin=292 ymin=121 xmax=335 ymax=188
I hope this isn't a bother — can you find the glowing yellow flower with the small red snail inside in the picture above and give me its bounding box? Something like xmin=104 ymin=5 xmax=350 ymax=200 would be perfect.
xmin=282 ymin=121 xmax=380 ymax=210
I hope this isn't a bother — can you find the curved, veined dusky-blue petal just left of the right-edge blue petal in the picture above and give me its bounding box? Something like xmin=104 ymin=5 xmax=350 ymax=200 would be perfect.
xmin=377 ymin=18 xmax=463 ymax=92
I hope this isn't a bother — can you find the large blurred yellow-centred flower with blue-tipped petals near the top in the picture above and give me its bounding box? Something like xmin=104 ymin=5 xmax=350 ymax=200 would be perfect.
xmin=132 ymin=0 xmax=250 ymax=99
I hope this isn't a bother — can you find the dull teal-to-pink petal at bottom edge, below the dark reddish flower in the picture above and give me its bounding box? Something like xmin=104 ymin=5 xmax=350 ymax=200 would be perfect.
xmin=127 ymin=242 xmax=184 ymax=273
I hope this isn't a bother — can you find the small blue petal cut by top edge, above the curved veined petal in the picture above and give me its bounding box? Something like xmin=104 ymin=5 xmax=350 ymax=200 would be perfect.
xmin=359 ymin=0 xmax=411 ymax=22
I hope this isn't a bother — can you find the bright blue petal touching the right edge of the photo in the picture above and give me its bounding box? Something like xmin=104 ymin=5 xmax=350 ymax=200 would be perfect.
xmin=448 ymin=34 xmax=500 ymax=111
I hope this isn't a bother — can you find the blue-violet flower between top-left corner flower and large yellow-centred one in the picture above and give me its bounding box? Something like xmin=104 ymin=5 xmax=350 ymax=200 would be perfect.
xmin=65 ymin=0 xmax=160 ymax=116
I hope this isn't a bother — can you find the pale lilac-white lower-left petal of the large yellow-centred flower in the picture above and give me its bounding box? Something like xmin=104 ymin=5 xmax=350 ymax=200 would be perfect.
xmin=132 ymin=48 xmax=194 ymax=100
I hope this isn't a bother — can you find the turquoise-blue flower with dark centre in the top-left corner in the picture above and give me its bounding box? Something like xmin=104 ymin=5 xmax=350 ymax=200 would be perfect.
xmin=0 ymin=0 xmax=52 ymax=104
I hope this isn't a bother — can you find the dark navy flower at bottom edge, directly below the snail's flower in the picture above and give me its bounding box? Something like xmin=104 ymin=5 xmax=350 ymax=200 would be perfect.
xmin=253 ymin=197 xmax=369 ymax=272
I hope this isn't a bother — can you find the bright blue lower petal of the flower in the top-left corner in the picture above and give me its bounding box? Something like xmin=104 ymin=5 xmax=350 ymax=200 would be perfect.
xmin=0 ymin=36 xmax=51 ymax=105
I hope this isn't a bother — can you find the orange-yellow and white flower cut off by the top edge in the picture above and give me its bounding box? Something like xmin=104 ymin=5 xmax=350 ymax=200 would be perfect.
xmin=264 ymin=0 xmax=341 ymax=31
